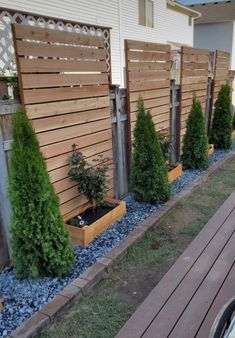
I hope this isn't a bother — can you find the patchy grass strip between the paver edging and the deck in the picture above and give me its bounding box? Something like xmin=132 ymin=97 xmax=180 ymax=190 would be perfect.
xmin=38 ymin=159 xmax=235 ymax=338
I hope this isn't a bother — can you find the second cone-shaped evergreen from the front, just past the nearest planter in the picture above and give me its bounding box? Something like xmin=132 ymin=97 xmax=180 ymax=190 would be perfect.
xmin=131 ymin=99 xmax=171 ymax=203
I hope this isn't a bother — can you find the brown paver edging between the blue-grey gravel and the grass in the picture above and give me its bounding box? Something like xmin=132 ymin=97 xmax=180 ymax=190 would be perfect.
xmin=8 ymin=151 xmax=235 ymax=338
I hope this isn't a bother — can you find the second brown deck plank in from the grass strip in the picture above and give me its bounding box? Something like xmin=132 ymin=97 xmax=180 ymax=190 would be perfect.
xmin=143 ymin=210 xmax=235 ymax=338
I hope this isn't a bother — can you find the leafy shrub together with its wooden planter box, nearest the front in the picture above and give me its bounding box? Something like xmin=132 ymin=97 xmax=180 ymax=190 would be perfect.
xmin=65 ymin=145 xmax=126 ymax=247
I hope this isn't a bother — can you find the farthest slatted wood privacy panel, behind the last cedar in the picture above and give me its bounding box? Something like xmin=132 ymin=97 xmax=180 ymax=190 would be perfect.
xmin=213 ymin=50 xmax=230 ymax=104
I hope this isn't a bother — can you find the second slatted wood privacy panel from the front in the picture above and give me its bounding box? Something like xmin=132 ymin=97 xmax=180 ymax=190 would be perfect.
xmin=125 ymin=40 xmax=171 ymax=140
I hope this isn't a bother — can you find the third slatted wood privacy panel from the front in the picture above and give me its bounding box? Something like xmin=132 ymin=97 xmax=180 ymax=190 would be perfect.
xmin=180 ymin=47 xmax=210 ymax=146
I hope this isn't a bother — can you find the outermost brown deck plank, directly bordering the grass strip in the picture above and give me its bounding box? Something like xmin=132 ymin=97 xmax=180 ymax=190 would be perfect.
xmin=116 ymin=193 xmax=235 ymax=338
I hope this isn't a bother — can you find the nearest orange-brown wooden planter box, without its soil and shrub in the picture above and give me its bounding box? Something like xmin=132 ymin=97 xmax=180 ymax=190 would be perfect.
xmin=65 ymin=199 xmax=126 ymax=248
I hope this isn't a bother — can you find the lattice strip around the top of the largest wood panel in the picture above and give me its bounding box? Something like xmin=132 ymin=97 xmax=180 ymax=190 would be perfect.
xmin=0 ymin=10 xmax=111 ymax=75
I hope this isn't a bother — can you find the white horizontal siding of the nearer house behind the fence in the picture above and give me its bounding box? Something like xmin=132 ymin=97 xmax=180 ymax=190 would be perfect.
xmin=1 ymin=0 xmax=193 ymax=85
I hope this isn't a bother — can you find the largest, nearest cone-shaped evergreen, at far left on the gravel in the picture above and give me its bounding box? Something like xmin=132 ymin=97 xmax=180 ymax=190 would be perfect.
xmin=9 ymin=109 xmax=74 ymax=278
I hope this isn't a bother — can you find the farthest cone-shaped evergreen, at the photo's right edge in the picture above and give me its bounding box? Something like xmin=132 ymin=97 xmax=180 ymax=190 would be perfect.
xmin=210 ymin=84 xmax=233 ymax=149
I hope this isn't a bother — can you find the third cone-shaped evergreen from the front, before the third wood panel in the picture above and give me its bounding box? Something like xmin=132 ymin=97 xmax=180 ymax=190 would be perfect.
xmin=183 ymin=97 xmax=208 ymax=169
